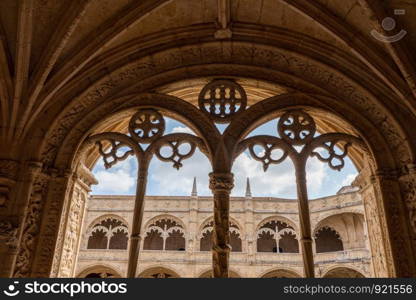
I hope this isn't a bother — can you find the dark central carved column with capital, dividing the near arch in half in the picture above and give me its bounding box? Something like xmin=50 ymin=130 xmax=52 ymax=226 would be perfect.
xmin=209 ymin=173 xmax=234 ymax=278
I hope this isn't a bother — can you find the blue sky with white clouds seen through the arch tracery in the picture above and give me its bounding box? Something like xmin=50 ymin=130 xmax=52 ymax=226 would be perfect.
xmin=92 ymin=118 xmax=357 ymax=199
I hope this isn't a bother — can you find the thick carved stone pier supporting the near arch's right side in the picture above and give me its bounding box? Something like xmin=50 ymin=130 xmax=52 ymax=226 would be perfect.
xmin=354 ymin=169 xmax=415 ymax=277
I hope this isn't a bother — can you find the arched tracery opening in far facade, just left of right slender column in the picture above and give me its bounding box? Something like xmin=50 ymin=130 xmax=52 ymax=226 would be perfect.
xmin=257 ymin=220 xmax=299 ymax=253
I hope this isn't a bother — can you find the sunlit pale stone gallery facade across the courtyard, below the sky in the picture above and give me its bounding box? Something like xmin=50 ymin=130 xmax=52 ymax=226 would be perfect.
xmin=73 ymin=189 xmax=373 ymax=278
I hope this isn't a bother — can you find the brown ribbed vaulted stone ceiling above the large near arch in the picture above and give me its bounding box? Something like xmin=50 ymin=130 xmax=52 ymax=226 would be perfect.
xmin=0 ymin=0 xmax=416 ymax=162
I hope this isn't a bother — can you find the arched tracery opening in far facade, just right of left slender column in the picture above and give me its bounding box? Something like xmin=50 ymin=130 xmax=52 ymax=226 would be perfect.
xmin=143 ymin=219 xmax=185 ymax=251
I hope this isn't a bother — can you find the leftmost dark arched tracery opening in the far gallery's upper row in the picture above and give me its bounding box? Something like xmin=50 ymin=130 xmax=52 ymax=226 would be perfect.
xmin=87 ymin=218 xmax=128 ymax=249
